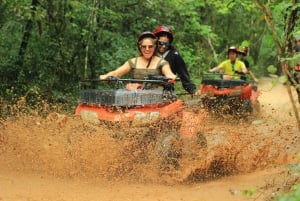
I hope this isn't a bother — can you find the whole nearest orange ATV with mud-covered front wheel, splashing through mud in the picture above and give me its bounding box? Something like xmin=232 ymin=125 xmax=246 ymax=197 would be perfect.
xmin=76 ymin=76 xmax=203 ymax=169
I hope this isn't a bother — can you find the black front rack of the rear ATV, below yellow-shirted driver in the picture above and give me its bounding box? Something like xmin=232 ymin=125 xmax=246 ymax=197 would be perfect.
xmin=201 ymin=78 xmax=247 ymax=88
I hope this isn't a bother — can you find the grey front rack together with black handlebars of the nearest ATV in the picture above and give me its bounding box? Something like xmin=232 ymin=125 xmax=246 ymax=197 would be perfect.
xmin=79 ymin=76 xmax=177 ymax=107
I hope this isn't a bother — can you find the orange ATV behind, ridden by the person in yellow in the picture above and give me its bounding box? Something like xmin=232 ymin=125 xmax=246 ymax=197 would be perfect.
xmin=200 ymin=73 xmax=260 ymax=116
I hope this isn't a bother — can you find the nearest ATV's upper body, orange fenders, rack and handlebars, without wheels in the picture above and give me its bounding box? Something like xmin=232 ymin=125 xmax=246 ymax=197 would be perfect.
xmin=76 ymin=76 xmax=182 ymax=125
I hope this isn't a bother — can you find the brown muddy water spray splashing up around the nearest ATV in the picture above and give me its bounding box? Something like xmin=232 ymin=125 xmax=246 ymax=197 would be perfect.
xmin=0 ymin=103 xmax=299 ymax=183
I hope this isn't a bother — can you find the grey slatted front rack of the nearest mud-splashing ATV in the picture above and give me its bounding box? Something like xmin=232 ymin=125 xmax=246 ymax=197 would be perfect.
xmin=79 ymin=89 xmax=170 ymax=106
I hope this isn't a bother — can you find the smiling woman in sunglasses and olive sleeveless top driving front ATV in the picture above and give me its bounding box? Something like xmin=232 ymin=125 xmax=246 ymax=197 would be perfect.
xmin=99 ymin=31 xmax=176 ymax=81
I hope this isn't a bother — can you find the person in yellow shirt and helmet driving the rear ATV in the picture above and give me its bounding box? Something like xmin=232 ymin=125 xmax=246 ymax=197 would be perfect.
xmin=209 ymin=46 xmax=247 ymax=79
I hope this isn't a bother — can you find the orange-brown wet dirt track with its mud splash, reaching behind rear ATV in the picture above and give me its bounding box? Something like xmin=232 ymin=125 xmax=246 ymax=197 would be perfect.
xmin=0 ymin=76 xmax=300 ymax=201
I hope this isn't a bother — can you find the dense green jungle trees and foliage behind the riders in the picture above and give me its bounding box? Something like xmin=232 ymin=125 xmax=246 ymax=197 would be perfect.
xmin=0 ymin=0 xmax=300 ymax=106
